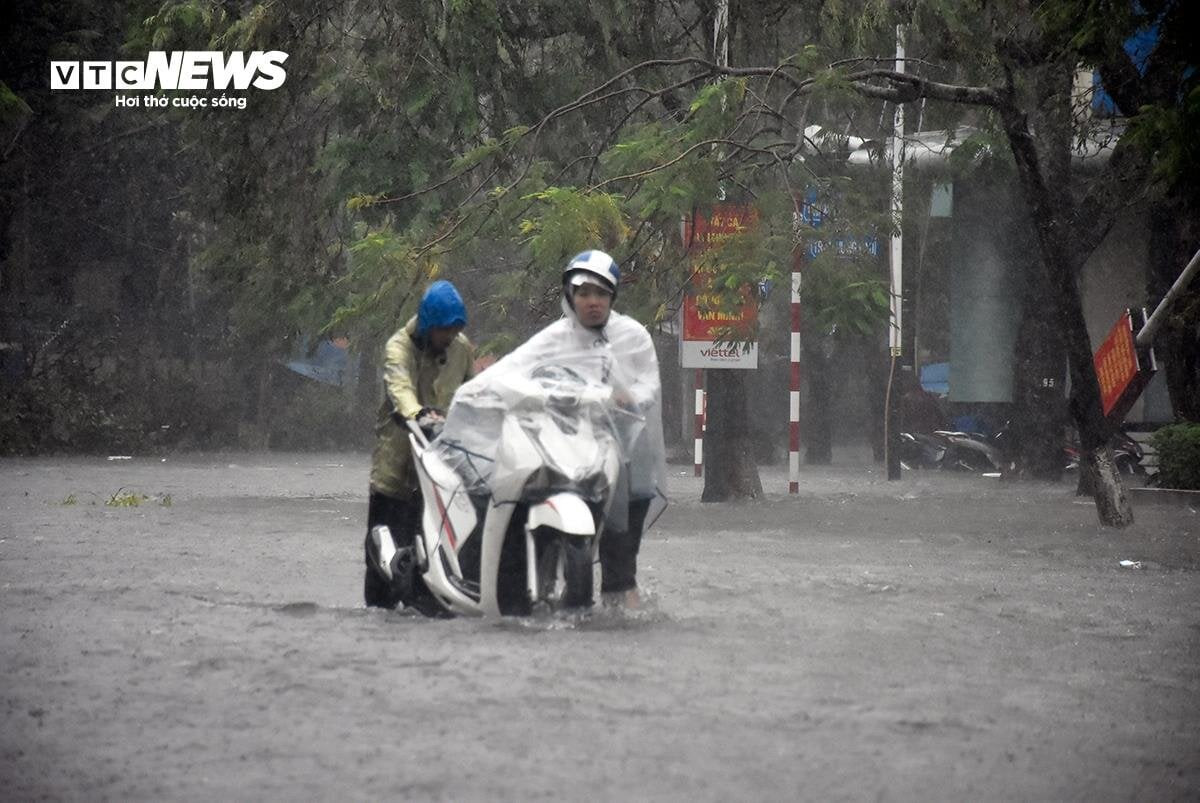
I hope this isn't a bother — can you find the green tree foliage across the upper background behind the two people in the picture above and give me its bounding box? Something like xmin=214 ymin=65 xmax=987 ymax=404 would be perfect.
xmin=0 ymin=0 xmax=1196 ymax=472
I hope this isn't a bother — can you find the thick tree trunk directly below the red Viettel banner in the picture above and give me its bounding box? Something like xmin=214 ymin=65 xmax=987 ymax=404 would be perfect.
xmin=700 ymin=368 xmax=762 ymax=502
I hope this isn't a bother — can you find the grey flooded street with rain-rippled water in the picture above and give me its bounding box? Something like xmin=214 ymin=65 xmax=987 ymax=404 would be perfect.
xmin=0 ymin=454 xmax=1200 ymax=801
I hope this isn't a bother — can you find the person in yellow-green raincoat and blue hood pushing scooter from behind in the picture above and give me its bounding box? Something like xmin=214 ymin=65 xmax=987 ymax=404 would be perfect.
xmin=362 ymin=281 xmax=474 ymax=609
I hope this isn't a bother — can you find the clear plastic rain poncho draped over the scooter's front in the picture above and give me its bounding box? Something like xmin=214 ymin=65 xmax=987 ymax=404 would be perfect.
xmin=434 ymin=305 xmax=666 ymax=523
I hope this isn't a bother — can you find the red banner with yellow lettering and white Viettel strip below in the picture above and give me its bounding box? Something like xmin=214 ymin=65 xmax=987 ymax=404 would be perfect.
xmin=680 ymin=204 xmax=758 ymax=368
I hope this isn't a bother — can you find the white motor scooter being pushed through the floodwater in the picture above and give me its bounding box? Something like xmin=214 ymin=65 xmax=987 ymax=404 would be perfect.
xmin=396 ymin=365 xmax=629 ymax=616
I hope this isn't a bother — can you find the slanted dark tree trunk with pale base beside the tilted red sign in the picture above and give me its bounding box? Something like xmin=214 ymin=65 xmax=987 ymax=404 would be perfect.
xmin=998 ymin=86 xmax=1133 ymax=527
